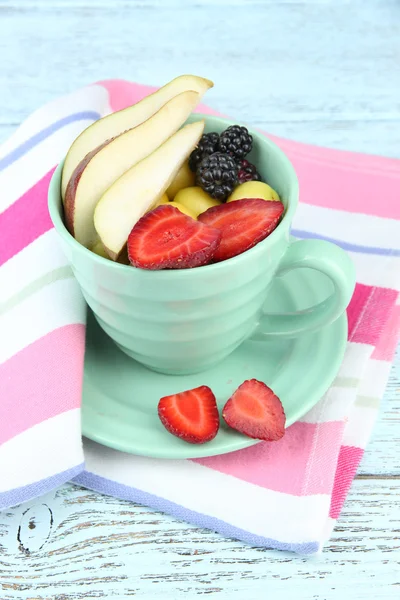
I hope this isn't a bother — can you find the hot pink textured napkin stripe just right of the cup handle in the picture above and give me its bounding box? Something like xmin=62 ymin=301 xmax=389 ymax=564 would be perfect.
xmin=347 ymin=283 xmax=398 ymax=346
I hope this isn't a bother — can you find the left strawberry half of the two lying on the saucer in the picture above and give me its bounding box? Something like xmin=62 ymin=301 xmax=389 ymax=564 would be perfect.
xmin=158 ymin=385 xmax=219 ymax=444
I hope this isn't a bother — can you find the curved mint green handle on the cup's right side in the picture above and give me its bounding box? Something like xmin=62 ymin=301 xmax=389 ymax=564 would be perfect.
xmin=250 ymin=240 xmax=355 ymax=341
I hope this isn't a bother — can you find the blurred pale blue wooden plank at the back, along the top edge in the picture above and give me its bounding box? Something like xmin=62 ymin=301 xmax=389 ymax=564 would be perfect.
xmin=0 ymin=0 xmax=400 ymax=144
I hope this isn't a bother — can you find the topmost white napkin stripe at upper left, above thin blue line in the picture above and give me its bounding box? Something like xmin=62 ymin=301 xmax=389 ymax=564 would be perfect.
xmin=0 ymin=85 xmax=111 ymax=158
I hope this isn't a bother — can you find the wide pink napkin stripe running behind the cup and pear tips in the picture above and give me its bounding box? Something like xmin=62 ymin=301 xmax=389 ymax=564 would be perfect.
xmin=99 ymin=80 xmax=400 ymax=219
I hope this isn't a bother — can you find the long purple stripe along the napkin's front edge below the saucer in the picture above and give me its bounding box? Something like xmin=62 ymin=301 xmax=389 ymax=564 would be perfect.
xmin=74 ymin=471 xmax=319 ymax=554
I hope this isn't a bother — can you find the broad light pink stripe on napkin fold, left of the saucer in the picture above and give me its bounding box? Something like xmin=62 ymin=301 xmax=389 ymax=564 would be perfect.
xmin=0 ymin=325 xmax=85 ymax=444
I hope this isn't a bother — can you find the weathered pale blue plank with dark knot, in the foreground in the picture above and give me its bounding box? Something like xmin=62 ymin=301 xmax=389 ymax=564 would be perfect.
xmin=0 ymin=479 xmax=400 ymax=600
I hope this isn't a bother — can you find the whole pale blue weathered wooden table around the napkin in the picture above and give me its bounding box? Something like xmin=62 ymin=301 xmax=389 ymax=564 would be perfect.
xmin=0 ymin=0 xmax=400 ymax=600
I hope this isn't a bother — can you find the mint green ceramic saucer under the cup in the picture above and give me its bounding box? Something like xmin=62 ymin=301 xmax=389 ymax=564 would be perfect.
xmin=82 ymin=269 xmax=347 ymax=459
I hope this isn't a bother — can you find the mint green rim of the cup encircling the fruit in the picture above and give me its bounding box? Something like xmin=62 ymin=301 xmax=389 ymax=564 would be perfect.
xmin=48 ymin=112 xmax=299 ymax=278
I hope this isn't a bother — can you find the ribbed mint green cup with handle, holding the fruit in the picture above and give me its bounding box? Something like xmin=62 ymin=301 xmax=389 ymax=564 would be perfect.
xmin=49 ymin=114 xmax=355 ymax=375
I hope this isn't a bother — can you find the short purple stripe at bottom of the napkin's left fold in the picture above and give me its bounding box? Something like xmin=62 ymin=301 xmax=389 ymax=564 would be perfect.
xmin=0 ymin=463 xmax=85 ymax=510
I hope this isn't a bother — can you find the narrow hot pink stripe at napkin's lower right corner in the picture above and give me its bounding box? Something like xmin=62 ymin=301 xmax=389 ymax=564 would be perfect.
xmin=329 ymin=446 xmax=364 ymax=519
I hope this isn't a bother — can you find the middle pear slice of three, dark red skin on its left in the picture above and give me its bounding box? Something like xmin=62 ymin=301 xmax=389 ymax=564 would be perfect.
xmin=64 ymin=91 xmax=199 ymax=248
